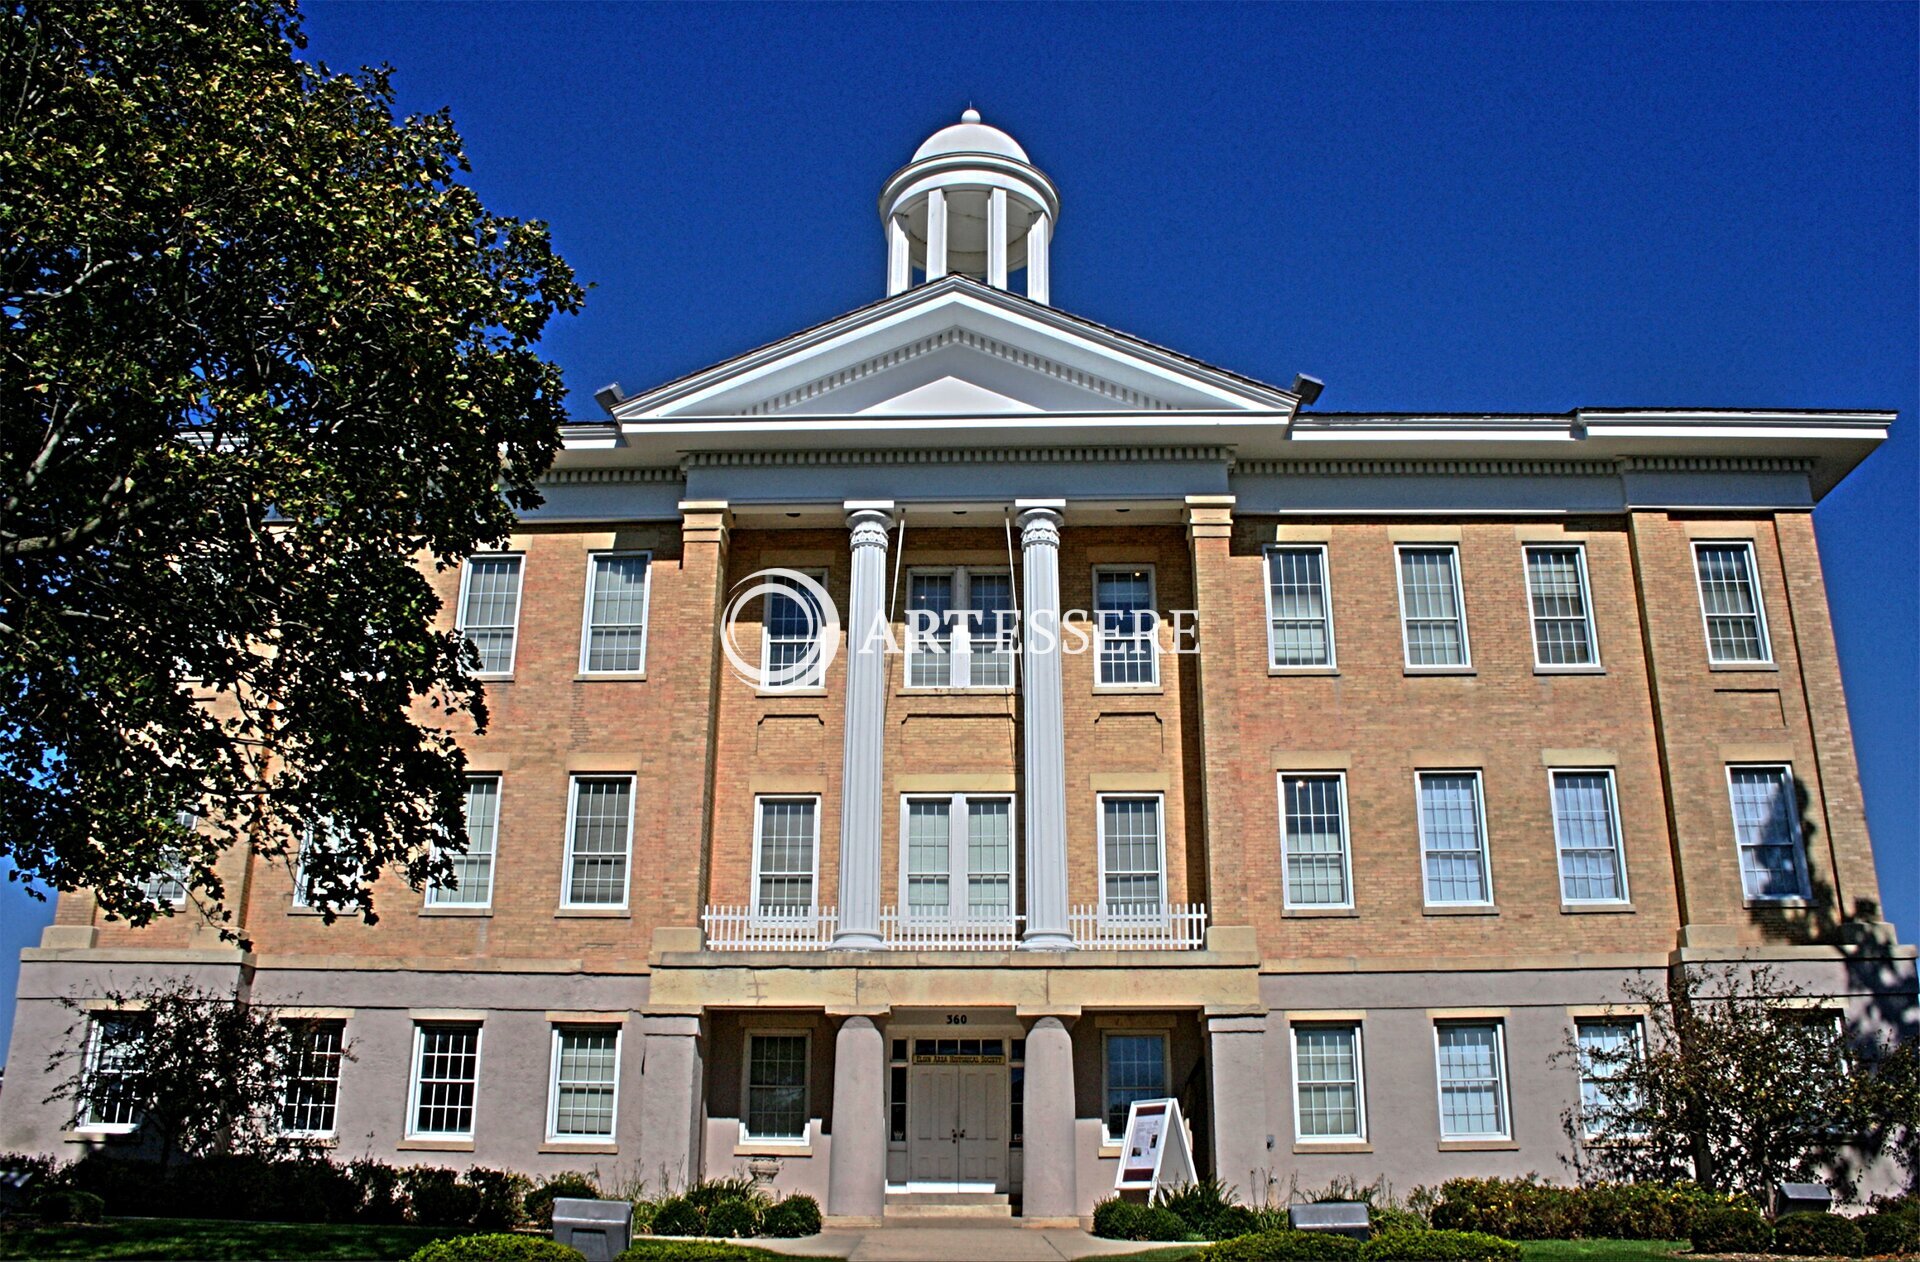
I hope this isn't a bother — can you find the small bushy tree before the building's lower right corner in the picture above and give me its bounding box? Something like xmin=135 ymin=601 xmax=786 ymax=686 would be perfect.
xmin=1559 ymin=966 xmax=1910 ymax=1204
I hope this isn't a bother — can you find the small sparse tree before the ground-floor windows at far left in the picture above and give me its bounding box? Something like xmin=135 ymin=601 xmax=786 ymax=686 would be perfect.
xmin=48 ymin=978 xmax=351 ymax=1166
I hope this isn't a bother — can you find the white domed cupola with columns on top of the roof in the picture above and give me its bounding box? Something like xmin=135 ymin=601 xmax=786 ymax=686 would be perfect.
xmin=879 ymin=109 xmax=1060 ymax=302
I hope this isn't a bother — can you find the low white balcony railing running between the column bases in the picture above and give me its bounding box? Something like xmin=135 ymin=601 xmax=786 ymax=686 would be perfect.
xmin=701 ymin=903 xmax=1206 ymax=951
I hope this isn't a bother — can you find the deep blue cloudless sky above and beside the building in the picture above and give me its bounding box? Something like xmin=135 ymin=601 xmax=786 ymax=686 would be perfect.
xmin=0 ymin=4 xmax=1920 ymax=1047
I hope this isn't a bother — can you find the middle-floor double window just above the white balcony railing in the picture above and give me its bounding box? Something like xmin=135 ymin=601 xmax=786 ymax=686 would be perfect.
xmin=900 ymin=793 xmax=1014 ymax=924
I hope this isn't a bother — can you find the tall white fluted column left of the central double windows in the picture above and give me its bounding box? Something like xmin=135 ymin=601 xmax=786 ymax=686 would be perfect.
xmin=833 ymin=499 xmax=893 ymax=951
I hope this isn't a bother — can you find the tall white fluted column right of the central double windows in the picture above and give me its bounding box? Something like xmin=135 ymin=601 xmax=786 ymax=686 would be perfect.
xmin=1014 ymin=499 xmax=1073 ymax=951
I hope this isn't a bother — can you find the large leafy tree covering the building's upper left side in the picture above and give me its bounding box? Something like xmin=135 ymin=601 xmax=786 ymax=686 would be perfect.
xmin=0 ymin=0 xmax=582 ymax=934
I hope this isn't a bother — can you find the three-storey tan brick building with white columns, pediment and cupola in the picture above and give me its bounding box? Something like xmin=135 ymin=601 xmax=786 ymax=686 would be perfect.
xmin=0 ymin=111 xmax=1914 ymax=1222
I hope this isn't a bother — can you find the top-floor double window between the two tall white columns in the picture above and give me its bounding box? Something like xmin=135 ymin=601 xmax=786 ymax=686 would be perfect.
xmin=906 ymin=565 xmax=1016 ymax=690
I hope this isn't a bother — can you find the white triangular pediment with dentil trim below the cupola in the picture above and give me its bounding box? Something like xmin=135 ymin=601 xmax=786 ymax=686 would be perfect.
xmin=616 ymin=277 xmax=1296 ymax=423
